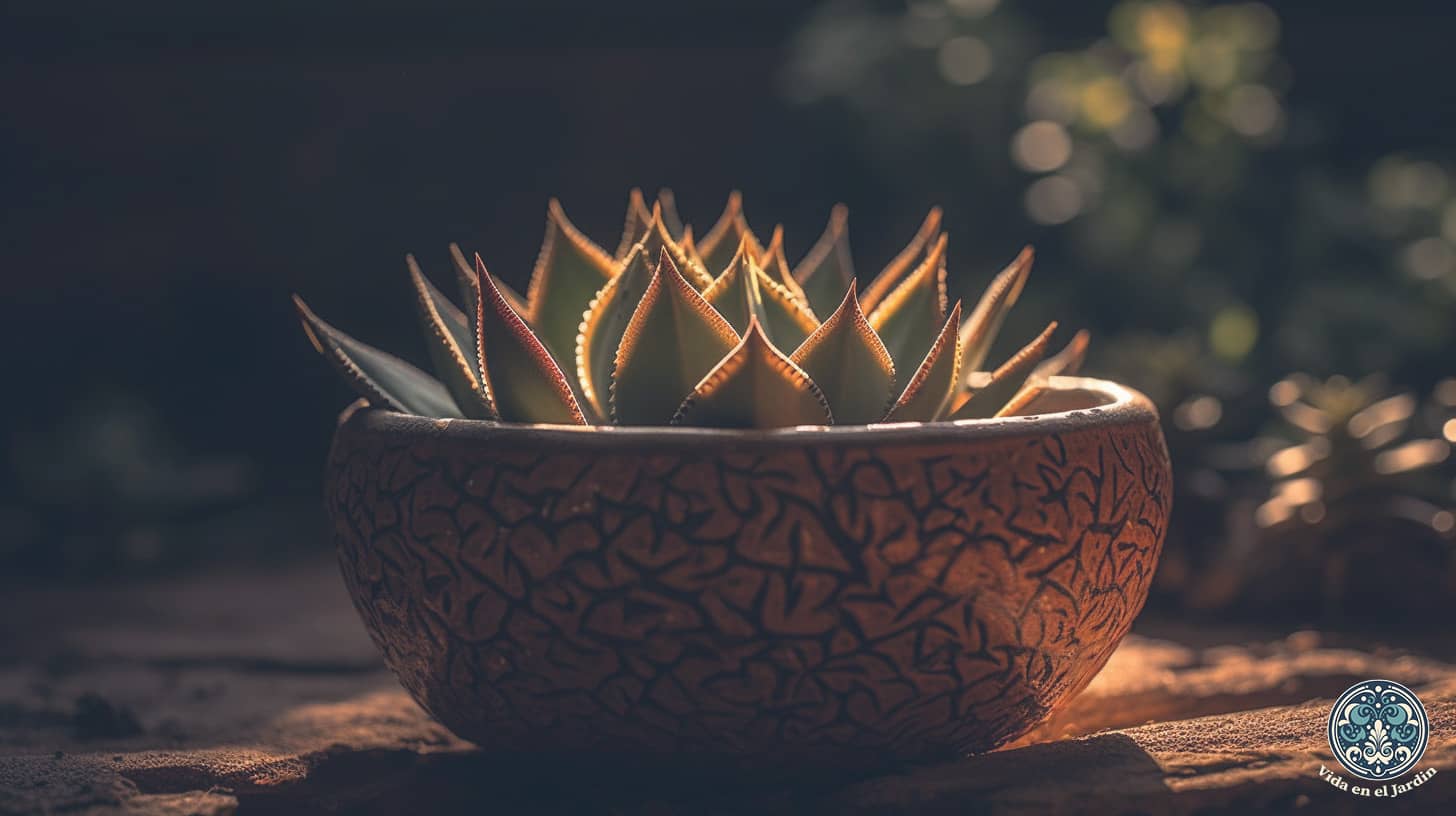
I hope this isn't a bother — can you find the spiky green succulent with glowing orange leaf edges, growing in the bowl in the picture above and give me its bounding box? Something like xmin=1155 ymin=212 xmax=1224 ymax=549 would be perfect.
xmin=294 ymin=189 xmax=1088 ymax=428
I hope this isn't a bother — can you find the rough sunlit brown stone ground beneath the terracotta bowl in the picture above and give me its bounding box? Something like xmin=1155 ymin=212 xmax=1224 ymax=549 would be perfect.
xmin=0 ymin=564 xmax=1456 ymax=815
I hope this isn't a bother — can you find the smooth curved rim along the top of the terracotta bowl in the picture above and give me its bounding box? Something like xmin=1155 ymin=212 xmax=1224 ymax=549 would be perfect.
xmin=339 ymin=377 xmax=1158 ymax=450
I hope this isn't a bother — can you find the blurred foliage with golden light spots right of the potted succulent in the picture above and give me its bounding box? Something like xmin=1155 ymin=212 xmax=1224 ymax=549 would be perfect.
xmin=783 ymin=0 xmax=1456 ymax=616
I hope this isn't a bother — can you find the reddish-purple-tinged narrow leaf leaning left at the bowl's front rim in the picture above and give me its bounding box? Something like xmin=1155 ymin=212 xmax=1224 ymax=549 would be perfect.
xmin=475 ymin=255 xmax=587 ymax=425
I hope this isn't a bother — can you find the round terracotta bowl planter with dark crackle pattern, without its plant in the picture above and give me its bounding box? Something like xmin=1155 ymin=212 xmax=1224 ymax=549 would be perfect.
xmin=328 ymin=377 xmax=1172 ymax=766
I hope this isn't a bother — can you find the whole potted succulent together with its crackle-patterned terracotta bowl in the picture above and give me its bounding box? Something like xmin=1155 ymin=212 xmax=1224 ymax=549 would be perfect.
xmin=297 ymin=191 xmax=1171 ymax=766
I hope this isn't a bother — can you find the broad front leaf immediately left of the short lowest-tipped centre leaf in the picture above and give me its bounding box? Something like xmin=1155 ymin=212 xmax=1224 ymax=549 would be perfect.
xmin=610 ymin=251 xmax=738 ymax=425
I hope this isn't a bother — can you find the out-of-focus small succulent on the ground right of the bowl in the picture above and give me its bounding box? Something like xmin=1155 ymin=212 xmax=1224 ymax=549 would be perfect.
xmin=1190 ymin=373 xmax=1456 ymax=615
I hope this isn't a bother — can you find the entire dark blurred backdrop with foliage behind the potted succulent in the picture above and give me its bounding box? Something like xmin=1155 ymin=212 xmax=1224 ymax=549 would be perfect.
xmin=0 ymin=0 xmax=1456 ymax=618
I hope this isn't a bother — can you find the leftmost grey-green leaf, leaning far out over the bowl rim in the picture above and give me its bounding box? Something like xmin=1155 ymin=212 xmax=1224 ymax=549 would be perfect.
xmin=293 ymin=294 xmax=462 ymax=418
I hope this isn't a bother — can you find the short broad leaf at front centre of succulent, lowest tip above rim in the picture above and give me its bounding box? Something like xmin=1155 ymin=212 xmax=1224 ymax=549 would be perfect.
xmin=673 ymin=319 xmax=834 ymax=428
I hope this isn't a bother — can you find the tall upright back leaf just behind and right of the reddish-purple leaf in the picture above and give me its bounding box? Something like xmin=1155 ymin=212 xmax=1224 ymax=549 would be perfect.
xmin=527 ymin=198 xmax=616 ymax=364
